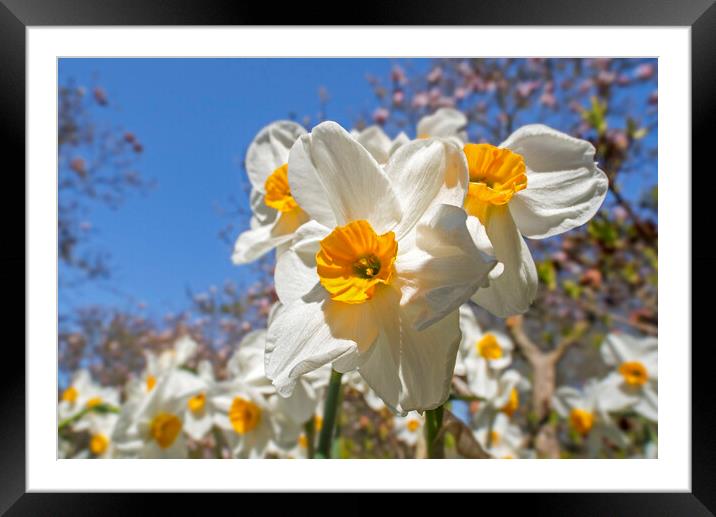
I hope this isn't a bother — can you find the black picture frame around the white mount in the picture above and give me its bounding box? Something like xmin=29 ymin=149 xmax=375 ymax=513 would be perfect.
xmin=0 ymin=0 xmax=716 ymax=516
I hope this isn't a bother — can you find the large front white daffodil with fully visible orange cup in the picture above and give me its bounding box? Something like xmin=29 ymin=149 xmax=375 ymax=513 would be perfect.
xmin=266 ymin=122 xmax=496 ymax=413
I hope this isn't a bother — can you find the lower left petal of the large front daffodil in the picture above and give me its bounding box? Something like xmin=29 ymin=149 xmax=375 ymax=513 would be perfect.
xmin=266 ymin=286 xmax=377 ymax=397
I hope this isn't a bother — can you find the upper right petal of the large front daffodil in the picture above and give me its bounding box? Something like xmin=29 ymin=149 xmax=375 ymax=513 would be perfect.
xmin=385 ymin=140 xmax=468 ymax=240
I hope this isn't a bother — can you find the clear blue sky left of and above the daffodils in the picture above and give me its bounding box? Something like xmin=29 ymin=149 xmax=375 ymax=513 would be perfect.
xmin=59 ymin=59 xmax=427 ymax=315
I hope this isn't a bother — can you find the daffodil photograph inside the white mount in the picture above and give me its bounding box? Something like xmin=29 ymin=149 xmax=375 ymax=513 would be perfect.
xmin=57 ymin=54 xmax=660 ymax=460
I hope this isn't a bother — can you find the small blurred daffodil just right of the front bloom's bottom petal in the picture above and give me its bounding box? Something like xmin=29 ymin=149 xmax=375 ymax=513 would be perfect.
xmin=455 ymin=304 xmax=514 ymax=398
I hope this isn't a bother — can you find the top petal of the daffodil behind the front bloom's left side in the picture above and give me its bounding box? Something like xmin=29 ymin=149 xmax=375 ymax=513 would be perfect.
xmin=246 ymin=120 xmax=306 ymax=192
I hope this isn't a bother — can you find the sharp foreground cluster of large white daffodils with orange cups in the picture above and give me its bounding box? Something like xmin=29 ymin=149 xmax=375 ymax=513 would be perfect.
xmin=233 ymin=109 xmax=608 ymax=415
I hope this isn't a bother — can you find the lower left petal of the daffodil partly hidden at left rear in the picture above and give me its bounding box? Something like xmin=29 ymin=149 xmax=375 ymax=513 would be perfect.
xmin=231 ymin=210 xmax=308 ymax=264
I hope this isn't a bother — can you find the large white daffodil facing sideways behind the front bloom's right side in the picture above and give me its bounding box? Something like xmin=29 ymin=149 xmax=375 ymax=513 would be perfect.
xmin=464 ymin=124 xmax=609 ymax=317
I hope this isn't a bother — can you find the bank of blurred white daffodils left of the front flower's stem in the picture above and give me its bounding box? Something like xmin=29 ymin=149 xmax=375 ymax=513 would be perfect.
xmin=58 ymin=330 xmax=383 ymax=458
